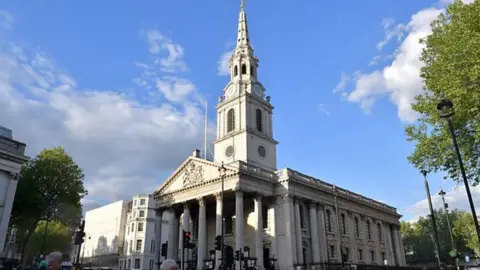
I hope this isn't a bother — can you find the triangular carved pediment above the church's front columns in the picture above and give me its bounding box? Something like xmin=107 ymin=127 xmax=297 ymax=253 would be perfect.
xmin=154 ymin=157 xmax=238 ymax=195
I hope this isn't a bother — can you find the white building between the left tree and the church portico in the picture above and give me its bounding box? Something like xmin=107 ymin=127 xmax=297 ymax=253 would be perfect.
xmin=79 ymin=195 xmax=159 ymax=269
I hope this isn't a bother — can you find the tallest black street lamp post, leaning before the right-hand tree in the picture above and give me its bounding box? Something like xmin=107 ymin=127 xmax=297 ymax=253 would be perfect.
xmin=437 ymin=99 xmax=480 ymax=247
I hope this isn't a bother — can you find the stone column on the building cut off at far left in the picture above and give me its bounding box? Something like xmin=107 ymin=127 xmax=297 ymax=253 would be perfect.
xmin=0 ymin=172 xmax=18 ymax=254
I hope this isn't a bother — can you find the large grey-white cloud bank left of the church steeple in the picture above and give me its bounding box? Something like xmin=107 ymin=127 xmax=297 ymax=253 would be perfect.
xmin=0 ymin=11 xmax=215 ymax=205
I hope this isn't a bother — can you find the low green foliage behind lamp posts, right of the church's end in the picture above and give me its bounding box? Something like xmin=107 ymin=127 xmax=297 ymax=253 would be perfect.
xmin=400 ymin=210 xmax=478 ymax=263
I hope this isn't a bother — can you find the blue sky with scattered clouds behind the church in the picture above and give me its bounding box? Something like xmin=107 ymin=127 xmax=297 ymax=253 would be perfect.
xmin=0 ymin=0 xmax=480 ymax=220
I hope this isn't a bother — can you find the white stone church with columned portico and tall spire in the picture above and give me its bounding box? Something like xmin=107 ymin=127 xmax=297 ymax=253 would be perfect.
xmin=153 ymin=2 xmax=405 ymax=269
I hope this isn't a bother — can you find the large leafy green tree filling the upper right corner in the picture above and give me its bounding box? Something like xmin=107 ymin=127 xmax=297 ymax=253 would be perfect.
xmin=405 ymin=0 xmax=480 ymax=185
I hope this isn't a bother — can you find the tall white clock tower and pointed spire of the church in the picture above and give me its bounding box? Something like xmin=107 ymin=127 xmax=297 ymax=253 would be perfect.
xmin=213 ymin=3 xmax=278 ymax=170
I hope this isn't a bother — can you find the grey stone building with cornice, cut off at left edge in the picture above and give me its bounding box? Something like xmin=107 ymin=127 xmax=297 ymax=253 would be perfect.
xmin=0 ymin=126 xmax=29 ymax=258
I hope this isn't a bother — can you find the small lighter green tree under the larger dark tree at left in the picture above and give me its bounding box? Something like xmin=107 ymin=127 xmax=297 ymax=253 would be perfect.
xmin=28 ymin=221 xmax=74 ymax=254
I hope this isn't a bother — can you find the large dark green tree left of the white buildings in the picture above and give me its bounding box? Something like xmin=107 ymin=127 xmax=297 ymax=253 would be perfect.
xmin=11 ymin=147 xmax=86 ymax=264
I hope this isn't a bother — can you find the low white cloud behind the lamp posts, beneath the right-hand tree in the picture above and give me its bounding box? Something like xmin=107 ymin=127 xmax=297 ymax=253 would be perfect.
xmin=406 ymin=185 xmax=480 ymax=221
